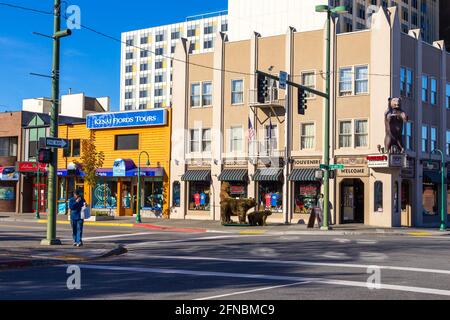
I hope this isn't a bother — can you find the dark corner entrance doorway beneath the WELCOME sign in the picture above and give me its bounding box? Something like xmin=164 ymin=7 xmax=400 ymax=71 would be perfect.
xmin=340 ymin=179 xmax=364 ymax=224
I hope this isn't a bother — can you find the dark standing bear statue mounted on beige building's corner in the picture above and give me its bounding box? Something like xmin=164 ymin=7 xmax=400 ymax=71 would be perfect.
xmin=384 ymin=98 xmax=408 ymax=154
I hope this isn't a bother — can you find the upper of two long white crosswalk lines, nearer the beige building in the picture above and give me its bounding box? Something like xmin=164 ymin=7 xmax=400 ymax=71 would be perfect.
xmin=128 ymin=255 xmax=450 ymax=275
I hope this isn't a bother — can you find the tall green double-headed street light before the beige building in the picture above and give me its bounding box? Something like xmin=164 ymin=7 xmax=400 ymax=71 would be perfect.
xmin=316 ymin=5 xmax=348 ymax=230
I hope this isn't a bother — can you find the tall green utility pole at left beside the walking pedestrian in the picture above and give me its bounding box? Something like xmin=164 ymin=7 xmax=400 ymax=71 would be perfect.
xmin=41 ymin=0 xmax=72 ymax=246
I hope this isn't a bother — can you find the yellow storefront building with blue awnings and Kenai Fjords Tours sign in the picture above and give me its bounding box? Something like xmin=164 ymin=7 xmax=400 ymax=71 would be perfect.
xmin=58 ymin=109 xmax=171 ymax=217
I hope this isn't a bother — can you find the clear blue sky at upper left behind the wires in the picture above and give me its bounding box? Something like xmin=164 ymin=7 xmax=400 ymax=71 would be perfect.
xmin=0 ymin=0 xmax=227 ymax=112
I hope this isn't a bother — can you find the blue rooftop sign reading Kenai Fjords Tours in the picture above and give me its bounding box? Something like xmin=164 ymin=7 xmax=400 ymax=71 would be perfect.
xmin=86 ymin=109 xmax=167 ymax=130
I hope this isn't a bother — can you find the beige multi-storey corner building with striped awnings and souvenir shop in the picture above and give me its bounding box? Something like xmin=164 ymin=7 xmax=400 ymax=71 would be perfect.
xmin=170 ymin=7 xmax=450 ymax=227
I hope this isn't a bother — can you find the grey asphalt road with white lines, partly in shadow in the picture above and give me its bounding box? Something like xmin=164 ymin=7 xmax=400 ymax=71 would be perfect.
xmin=0 ymin=223 xmax=450 ymax=300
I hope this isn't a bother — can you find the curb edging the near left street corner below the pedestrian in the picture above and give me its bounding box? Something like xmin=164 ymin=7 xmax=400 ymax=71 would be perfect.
xmin=0 ymin=245 xmax=128 ymax=271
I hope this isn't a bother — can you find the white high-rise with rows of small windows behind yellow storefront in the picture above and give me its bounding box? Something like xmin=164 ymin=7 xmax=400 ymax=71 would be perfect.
xmin=120 ymin=11 xmax=228 ymax=110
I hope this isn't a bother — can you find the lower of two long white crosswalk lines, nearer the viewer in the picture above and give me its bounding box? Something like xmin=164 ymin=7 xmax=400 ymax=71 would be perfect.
xmin=69 ymin=265 xmax=450 ymax=297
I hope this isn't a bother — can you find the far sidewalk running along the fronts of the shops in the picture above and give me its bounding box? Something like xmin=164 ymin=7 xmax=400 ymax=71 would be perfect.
xmin=0 ymin=214 xmax=450 ymax=237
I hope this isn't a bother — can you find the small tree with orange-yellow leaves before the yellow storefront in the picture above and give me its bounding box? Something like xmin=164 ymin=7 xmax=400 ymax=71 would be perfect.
xmin=80 ymin=131 xmax=105 ymax=206
